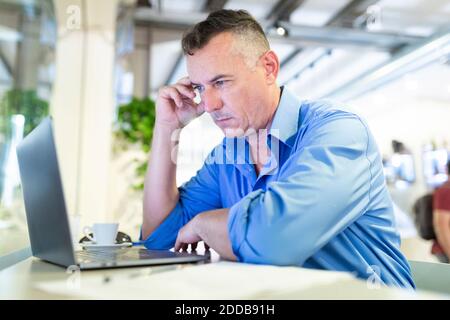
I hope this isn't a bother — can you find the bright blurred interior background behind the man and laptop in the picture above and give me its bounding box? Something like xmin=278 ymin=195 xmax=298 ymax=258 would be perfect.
xmin=0 ymin=0 xmax=450 ymax=261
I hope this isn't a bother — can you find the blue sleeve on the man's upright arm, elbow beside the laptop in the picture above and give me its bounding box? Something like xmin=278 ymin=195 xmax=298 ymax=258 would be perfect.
xmin=141 ymin=149 xmax=222 ymax=250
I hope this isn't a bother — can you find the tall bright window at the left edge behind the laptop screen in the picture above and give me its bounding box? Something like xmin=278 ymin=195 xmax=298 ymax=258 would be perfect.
xmin=0 ymin=0 xmax=56 ymax=256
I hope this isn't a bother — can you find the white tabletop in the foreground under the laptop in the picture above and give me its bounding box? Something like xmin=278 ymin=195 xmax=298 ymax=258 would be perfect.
xmin=0 ymin=248 xmax=446 ymax=299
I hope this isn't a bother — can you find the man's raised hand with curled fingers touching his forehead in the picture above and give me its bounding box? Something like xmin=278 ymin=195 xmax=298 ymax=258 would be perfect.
xmin=156 ymin=77 xmax=204 ymax=129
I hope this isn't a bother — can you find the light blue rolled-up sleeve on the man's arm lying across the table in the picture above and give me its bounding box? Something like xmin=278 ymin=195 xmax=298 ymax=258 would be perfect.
xmin=228 ymin=114 xmax=372 ymax=265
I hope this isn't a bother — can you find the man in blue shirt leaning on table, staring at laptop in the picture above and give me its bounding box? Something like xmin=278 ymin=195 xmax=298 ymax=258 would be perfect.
xmin=142 ymin=10 xmax=414 ymax=288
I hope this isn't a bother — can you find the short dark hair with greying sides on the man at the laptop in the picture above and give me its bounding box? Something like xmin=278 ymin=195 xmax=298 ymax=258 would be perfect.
xmin=181 ymin=9 xmax=270 ymax=63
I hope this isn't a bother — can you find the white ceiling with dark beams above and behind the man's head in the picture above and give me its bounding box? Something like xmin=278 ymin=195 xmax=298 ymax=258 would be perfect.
xmin=131 ymin=0 xmax=450 ymax=100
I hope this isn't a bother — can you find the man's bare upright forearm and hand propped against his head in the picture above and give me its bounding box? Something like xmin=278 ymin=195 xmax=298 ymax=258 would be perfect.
xmin=142 ymin=78 xmax=204 ymax=239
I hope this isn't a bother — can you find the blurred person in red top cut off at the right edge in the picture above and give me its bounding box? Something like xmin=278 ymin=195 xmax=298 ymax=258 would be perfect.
xmin=432 ymin=160 xmax=450 ymax=263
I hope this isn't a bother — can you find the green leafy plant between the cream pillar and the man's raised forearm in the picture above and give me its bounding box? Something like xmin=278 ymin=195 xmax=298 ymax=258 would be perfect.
xmin=116 ymin=98 xmax=156 ymax=190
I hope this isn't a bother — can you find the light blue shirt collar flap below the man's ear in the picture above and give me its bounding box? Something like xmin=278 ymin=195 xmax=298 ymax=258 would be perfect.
xmin=269 ymin=87 xmax=301 ymax=147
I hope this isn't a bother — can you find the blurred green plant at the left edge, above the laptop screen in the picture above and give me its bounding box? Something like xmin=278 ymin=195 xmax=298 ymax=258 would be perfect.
xmin=0 ymin=89 xmax=48 ymax=136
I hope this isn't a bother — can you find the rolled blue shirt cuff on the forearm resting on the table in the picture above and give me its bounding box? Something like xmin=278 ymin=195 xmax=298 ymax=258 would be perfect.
xmin=227 ymin=190 xmax=263 ymax=262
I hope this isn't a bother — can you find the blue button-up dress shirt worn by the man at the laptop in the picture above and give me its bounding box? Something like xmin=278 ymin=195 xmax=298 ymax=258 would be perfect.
xmin=144 ymin=88 xmax=414 ymax=288
